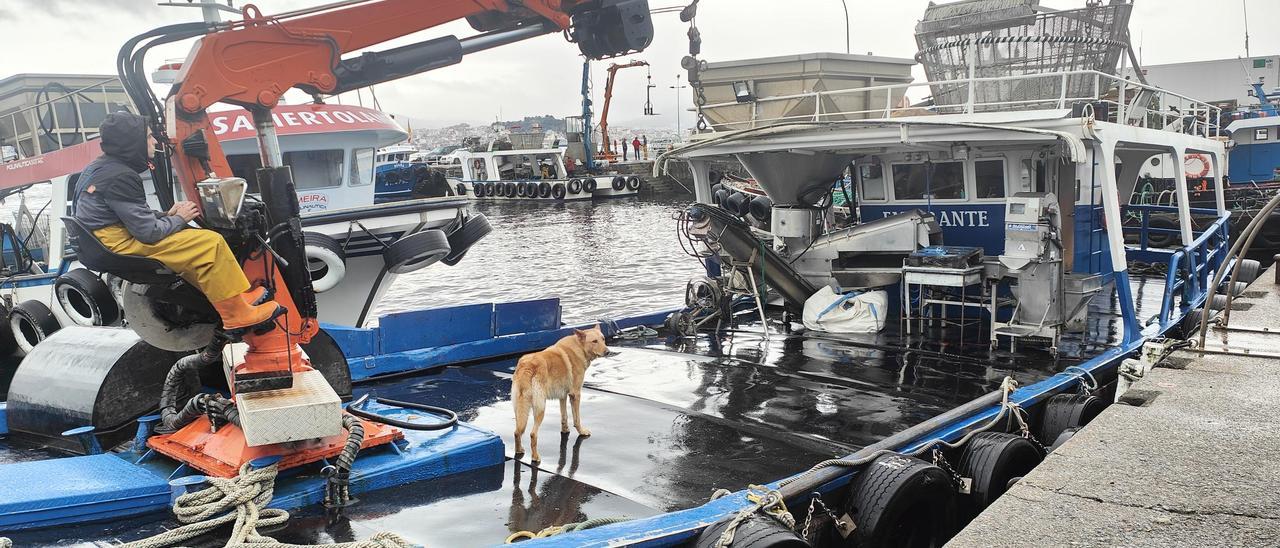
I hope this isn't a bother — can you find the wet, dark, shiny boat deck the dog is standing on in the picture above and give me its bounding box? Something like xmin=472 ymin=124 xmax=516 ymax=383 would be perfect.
xmin=0 ymin=272 xmax=1164 ymax=547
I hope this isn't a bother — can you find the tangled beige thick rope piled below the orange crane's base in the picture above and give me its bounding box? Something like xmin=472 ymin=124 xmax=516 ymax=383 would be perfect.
xmin=122 ymin=463 xmax=413 ymax=548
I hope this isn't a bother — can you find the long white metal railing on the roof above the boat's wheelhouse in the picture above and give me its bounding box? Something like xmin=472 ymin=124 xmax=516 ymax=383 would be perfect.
xmin=701 ymin=70 xmax=1222 ymax=137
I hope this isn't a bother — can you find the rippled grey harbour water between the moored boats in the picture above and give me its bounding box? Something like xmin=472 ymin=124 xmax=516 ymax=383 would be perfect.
xmin=374 ymin=198 xmax=703 ymax=323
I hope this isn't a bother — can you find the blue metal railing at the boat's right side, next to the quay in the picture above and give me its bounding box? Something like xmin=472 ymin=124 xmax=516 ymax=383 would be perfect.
xmin=1125 ymin=205 xmax=1231 ymax=329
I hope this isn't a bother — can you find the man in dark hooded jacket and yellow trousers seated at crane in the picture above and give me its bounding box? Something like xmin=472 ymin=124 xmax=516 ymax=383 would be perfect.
xmin=73 ymin=111 xmax=278 ymax=329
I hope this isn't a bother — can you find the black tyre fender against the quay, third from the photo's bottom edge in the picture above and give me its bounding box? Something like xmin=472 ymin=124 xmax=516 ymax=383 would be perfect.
xmin=956 ymin=431 xmax=1044 ymax=517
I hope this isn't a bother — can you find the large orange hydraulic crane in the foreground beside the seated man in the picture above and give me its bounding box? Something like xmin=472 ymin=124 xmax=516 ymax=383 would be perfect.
xmin=106 ymin=0 xmax=653 ymax=472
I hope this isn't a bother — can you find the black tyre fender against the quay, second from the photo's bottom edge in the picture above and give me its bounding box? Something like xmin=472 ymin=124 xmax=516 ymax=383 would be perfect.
xmin=822 ymin=455 xmax=955 ymax=547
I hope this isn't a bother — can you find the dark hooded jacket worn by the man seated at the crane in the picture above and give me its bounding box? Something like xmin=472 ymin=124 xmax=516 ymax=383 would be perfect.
xmin=74 ymin=111 xmax=187 ymax=243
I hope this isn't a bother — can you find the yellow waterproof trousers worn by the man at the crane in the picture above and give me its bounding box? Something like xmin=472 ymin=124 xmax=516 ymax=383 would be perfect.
xmin=93 ymin=224 xmax=248 ymax=302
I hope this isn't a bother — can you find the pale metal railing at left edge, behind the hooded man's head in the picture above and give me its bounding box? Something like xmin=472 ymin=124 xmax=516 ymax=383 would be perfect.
xmin=0 ymin=77 xmax=132 ymax=161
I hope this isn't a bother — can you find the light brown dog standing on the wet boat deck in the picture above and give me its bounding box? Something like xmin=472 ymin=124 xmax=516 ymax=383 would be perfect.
xmin=511 ymin=325 xmax=609 ymax=462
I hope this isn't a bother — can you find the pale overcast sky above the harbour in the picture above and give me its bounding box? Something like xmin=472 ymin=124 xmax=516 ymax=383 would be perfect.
xmin=0 ymin=0 xmax=1280 ymax=128
